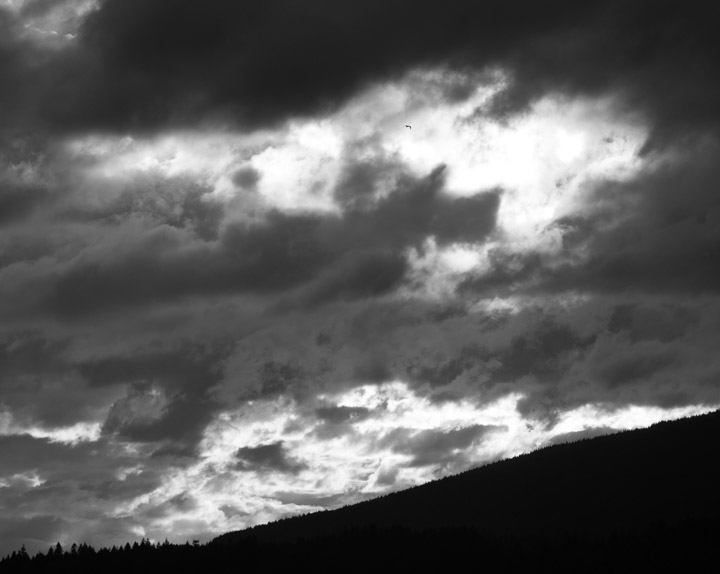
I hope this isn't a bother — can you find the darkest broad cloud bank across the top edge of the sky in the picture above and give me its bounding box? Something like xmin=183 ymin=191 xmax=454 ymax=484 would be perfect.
xmin=0 ymin=0 xmax=720 ymax=148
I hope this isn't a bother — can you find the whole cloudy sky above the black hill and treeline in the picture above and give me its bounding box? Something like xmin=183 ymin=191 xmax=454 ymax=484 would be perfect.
xmin=0 ymin=0 xmax=720 ymax=554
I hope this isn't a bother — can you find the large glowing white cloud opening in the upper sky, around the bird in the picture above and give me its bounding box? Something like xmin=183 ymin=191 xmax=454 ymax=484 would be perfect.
xmin=63 ymin=71 xmax=647 ymax=286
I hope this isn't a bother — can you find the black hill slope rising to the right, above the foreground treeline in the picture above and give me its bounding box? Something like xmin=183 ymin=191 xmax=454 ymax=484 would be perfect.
xmin=213 ymin=412 xmax=720 ymax=544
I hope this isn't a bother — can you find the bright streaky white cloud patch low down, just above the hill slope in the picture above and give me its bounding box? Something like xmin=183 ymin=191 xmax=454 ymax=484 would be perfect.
xmin=112 ymin=381 xmax=712 ymax=544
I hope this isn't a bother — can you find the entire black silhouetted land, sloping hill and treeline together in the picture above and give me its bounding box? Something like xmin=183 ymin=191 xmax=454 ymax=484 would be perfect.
xmin=5 ymin=412 xmax=720 ymax=572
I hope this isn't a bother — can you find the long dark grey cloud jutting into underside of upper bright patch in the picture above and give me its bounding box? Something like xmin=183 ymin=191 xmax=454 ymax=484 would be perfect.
xmin=28 ymin=168 xmax=500 ymax=318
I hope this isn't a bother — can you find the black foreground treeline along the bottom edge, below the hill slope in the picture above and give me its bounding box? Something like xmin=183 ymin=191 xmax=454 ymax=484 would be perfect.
xmin=0 ymin=522 xmax=718 ymax=574
